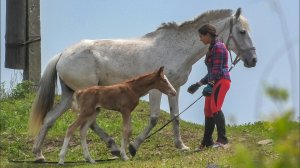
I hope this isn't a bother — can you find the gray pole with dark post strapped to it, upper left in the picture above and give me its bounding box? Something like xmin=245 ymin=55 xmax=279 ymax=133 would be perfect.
xmin=5 ymin=0 xmax=41 ymax=84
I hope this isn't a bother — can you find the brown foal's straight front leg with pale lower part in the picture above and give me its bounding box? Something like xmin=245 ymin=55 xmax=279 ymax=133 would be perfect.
xmin=121 ymin=111 xmax=132 ymax=160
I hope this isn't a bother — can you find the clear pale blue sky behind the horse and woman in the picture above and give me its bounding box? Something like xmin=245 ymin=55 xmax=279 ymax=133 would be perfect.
xmin=1 ymin=0 xmax=299 ymax=124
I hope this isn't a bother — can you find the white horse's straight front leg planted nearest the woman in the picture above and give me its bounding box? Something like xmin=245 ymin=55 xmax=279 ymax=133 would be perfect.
xmin=168 ymin=88 xmax=190 ymax=150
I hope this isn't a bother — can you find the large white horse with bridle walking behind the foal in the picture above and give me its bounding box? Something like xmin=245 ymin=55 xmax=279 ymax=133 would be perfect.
xmin=29 ymin=8 xmax=257 ymax=161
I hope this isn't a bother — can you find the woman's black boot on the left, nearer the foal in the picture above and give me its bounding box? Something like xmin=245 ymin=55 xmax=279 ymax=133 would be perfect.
xmin=201 ymin=117 xmax=215 ymax=147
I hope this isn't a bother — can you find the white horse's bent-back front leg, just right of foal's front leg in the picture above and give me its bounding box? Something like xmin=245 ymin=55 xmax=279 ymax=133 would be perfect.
xmin=129 ymin=90 xmax=162 ymax=156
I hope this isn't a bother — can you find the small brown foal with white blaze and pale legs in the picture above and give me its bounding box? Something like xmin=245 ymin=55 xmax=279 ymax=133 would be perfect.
xmin=59 ymin=67 xmax=176 ymax=164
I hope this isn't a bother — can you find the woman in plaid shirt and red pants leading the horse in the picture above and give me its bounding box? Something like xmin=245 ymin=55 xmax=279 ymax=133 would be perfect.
xmin=188 ymin=24 xmax=231 ymax=151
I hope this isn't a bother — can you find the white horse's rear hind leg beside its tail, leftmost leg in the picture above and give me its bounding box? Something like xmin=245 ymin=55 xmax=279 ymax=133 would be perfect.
xmin=33 ymin=82 xmax=73 ymax=162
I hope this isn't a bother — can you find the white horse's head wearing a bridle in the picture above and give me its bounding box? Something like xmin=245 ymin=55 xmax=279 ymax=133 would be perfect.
xmin=223 ymin=8 xmax=257 ymax=68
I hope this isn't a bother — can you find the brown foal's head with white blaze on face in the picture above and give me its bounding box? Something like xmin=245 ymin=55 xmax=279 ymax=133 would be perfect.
xmin=155 ymin=66 xmax=176 ymax=96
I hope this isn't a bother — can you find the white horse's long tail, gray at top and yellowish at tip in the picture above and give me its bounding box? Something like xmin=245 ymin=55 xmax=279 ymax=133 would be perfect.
xmin=28 ymin=54 xmax=61 ymax=136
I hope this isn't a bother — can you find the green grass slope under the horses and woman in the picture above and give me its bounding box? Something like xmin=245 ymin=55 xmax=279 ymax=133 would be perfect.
xmin=0 ymin=89 xmax=299 ymax=168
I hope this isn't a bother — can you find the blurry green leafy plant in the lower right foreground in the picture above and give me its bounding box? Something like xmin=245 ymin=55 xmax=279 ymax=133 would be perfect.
xmin=231 ymin=86 xmax=300 ymax=168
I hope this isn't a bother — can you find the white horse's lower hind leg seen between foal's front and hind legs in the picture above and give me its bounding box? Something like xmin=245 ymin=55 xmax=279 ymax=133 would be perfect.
xmin=91 ymin=121 xmax=120 ymax=157
